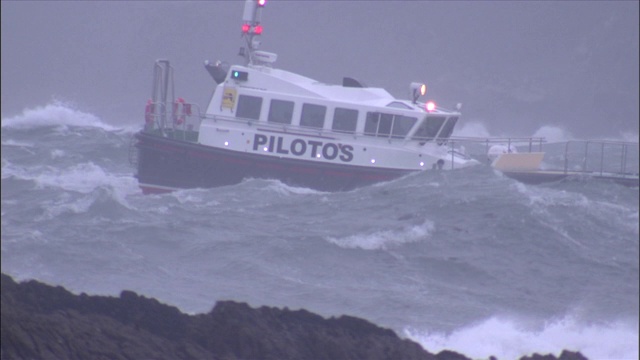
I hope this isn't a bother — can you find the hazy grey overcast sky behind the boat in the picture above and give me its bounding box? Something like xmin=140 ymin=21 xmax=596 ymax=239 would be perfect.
xmin=1 ymin=0 xmax=640 ymax=137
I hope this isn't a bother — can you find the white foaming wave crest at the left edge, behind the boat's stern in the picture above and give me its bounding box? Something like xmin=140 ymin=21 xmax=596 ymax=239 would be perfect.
xmin=2 ymin=101 xmax=117 ymax=131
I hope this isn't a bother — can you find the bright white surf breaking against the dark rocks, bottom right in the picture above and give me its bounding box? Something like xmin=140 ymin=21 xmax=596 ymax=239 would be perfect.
xmin=404 ymin=316 xmax=638 ymax=360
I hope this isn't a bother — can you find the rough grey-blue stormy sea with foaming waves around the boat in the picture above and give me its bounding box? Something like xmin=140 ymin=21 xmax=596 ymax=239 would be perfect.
xmin=1 ymin=103 xmax=639 ymax=359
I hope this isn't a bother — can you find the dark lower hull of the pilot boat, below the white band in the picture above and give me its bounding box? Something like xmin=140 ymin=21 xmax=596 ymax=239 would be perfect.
xmin=135 ymin=131 xmax=412 ymax=193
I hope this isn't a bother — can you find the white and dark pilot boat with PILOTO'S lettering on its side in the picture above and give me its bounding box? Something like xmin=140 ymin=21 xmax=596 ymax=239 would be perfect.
xmin=132 ymin=0 xmax=479 ymax=194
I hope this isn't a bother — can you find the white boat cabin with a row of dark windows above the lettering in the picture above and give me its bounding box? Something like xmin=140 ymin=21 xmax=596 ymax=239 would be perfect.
xmin=207 ymin=61 xmax=460 ymax=144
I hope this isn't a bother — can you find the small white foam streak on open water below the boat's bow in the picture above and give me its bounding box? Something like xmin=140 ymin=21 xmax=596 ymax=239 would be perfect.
xmin=327 ymin=220 xmax=434 ymax=250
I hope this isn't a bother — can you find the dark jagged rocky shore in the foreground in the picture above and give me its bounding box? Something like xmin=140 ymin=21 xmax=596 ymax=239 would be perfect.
xmin=0 ymin=274 xmax=586 ymax=360
